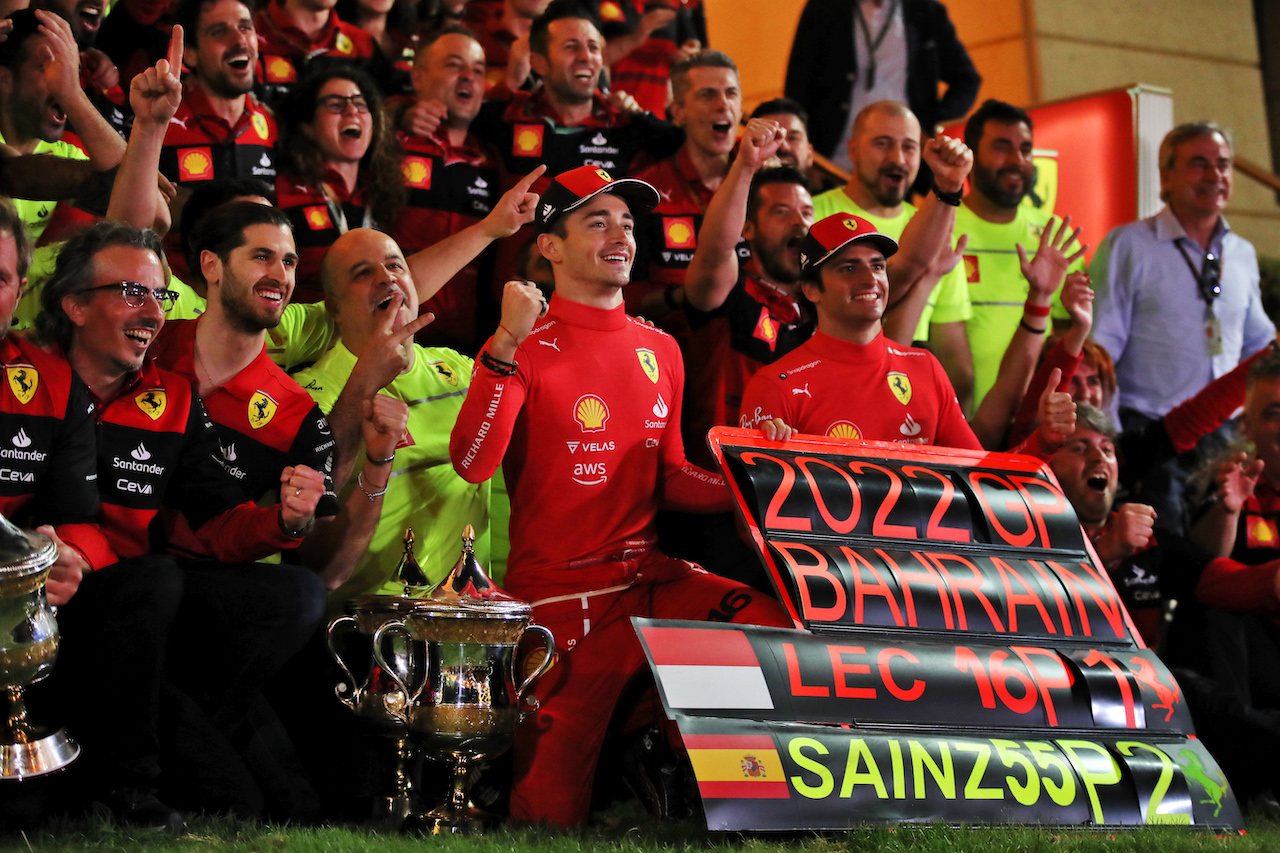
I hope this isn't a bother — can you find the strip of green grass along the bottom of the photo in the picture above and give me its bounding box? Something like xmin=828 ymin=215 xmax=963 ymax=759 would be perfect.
xmin=0 ymin=807 xmax=1280 ymax=853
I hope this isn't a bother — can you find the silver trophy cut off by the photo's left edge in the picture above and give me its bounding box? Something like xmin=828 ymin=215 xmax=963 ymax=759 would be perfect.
xmin=0 ymin=516 xmax=79 ymax=779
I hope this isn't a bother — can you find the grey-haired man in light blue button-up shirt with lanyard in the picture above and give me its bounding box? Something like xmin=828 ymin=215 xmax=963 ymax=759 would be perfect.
xmin=1089 ymin=122 xmax=1276 ymax=532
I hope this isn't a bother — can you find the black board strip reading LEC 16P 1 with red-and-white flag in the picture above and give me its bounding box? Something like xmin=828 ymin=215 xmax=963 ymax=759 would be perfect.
xmin=632 ymin=619 xmax=1192 ymax=734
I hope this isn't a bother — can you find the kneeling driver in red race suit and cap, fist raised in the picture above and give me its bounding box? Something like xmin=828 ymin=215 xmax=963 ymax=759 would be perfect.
xmin=449 ymin=167 xmax=792 ymax=825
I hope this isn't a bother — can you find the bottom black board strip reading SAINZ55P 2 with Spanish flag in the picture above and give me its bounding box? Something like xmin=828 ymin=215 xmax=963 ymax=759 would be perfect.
xmin=677 ymin=716 xmax=1243 ymax=830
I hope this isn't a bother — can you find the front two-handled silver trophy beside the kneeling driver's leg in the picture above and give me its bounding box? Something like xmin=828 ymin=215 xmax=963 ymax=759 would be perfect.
xmin=372 ymin=525 xmax=556 ymax=834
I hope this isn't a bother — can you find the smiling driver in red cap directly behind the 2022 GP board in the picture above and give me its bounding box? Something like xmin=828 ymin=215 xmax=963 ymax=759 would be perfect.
xmin=740 ymin=214 xmax=982 ymax=450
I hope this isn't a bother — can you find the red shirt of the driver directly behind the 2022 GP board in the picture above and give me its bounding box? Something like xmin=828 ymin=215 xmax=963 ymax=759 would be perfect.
xmin=740 ymin=326 xmax=982 ymax=450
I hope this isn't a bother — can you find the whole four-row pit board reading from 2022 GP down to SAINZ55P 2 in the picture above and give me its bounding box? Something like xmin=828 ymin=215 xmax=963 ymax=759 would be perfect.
xmin=634 ymin=428 xmax=1242 ymax=830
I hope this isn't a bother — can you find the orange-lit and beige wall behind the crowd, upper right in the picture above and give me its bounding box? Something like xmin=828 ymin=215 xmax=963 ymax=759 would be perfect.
xmin=707 ymin=0 xmax=1280 ymax=249
